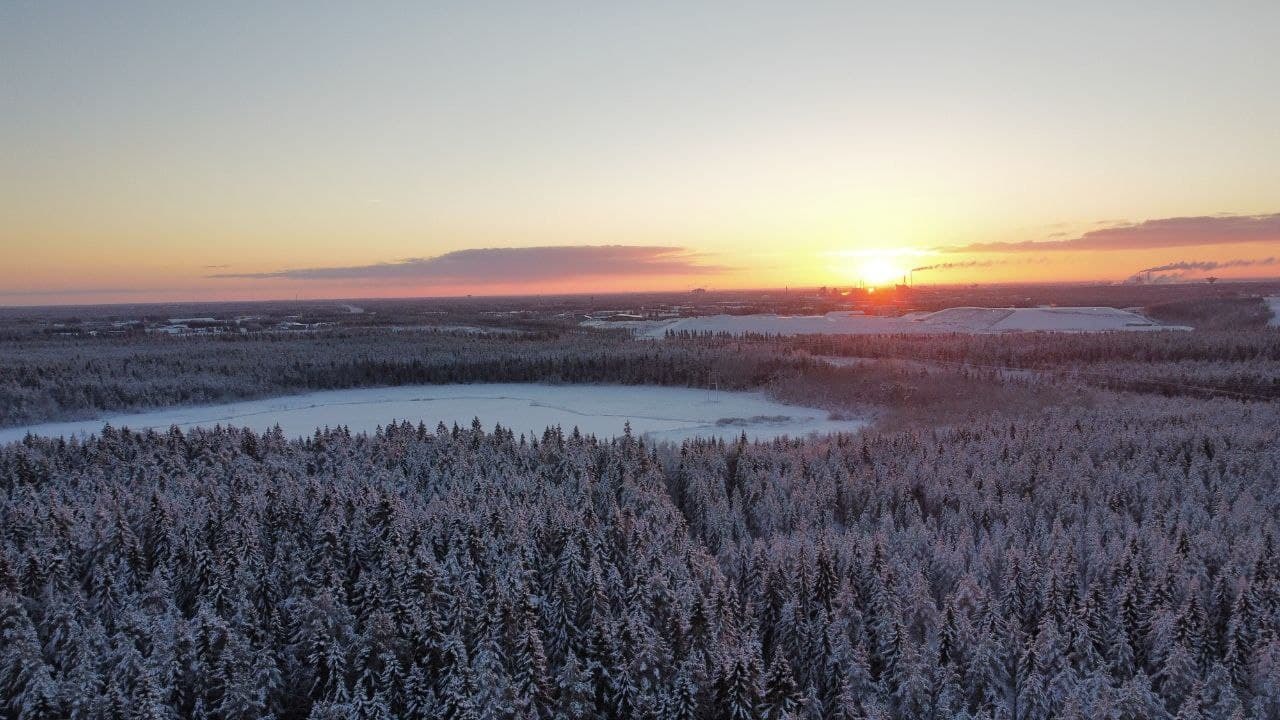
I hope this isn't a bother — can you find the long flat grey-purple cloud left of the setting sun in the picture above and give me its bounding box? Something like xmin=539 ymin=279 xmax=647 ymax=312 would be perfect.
xmin=207 ymin=245 xmax=728 ymax=283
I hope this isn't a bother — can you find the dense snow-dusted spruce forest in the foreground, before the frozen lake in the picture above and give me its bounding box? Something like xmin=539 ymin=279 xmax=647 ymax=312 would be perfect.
xmin=0 ymin=396 xmax=1280 ymax=720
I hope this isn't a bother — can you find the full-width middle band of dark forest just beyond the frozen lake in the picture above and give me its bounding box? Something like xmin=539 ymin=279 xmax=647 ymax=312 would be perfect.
xmin=0 ymin=319 xmax=1280 ymax=427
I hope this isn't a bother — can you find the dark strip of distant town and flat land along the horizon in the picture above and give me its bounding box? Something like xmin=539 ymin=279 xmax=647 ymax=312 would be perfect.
xmin=0 ymin=281 xmax=1280 ymax=337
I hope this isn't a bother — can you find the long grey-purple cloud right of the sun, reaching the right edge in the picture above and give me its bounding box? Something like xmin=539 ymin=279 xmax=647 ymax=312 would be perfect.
xmin=937 ymin=213 xmax=1280 ymax=252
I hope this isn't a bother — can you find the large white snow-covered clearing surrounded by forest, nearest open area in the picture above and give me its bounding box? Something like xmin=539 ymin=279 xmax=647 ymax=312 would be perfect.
xmin=0 ymin=383 xmax=865 ymax=443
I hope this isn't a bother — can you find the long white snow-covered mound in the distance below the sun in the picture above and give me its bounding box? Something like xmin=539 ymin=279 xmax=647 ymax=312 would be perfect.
xmin=595 ymin=302 xmax=1190 ymax=338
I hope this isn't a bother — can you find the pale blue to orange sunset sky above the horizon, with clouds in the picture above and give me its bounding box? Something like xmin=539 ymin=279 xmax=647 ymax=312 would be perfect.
xmin=0 ymin=0 xmax=1280 ymax=305
